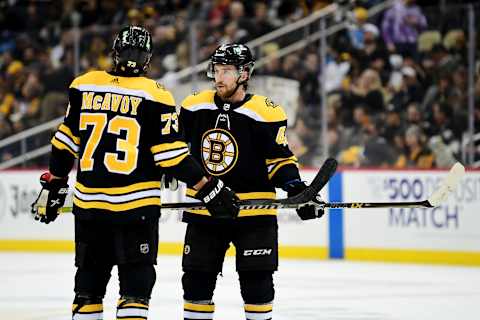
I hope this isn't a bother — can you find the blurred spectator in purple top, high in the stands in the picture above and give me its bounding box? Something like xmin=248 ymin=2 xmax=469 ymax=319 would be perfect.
xmin=382 ymin=0 xmax=427 ymax=56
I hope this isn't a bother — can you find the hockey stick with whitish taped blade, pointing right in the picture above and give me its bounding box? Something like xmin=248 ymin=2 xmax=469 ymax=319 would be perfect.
xmin=319 ymin=162 xmax=465 ymax=209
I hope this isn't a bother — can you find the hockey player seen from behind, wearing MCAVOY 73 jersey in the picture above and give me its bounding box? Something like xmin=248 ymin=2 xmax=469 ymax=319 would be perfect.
xmin=33 ymin=26 xmax=238 ymax=320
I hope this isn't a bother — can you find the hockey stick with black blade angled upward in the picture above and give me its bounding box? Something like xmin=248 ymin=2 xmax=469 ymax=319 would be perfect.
xmin=38 ymin=158 xmax=337 ymax=214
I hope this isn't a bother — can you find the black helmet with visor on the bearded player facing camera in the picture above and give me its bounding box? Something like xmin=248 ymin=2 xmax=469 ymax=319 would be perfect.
xmin=207 ymin=43 xmax=255 ymax=79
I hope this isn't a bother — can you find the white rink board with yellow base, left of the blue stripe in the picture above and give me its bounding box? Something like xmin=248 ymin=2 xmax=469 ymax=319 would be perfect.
xmin=0 ymin=170 xmax=328 ymax=259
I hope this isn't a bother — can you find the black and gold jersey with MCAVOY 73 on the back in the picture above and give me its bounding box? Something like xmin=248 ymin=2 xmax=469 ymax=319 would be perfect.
xmin=50 ymin=71 xmax=203 ymax=220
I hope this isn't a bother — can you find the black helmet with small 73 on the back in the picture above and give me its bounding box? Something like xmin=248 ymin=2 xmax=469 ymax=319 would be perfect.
xmin=112 ymin=26 xmax=153 ymax=76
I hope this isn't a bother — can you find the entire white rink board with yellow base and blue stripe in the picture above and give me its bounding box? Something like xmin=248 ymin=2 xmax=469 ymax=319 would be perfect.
xmin=0 ymin=170 xmax=480 ymax=266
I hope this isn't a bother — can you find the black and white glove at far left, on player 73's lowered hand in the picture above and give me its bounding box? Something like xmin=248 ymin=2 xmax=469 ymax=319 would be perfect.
xmin=32 ymin=172 xmax=68 ymax=224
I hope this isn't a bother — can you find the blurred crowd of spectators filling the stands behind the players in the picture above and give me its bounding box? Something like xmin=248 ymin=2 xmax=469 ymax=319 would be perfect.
xmin=0 ymin=0 xmax=480 ymax=168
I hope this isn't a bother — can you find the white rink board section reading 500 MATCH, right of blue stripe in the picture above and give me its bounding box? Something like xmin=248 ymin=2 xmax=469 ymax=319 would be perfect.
xmin=336 ymin=170 xmax=480 ymax=266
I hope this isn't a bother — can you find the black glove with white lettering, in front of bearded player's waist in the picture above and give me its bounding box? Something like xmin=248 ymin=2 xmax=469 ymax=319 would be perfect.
xmin=197 ymin=177 xmax=240 ymax=219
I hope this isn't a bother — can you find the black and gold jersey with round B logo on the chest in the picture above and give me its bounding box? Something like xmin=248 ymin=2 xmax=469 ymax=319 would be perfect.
xmin=180 ymin=90 xmax=299 ymax=222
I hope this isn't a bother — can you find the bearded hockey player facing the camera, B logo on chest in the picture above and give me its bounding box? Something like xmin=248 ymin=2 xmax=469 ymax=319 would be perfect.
xmin=180 ymin=44 xmax=323 ymax=320
